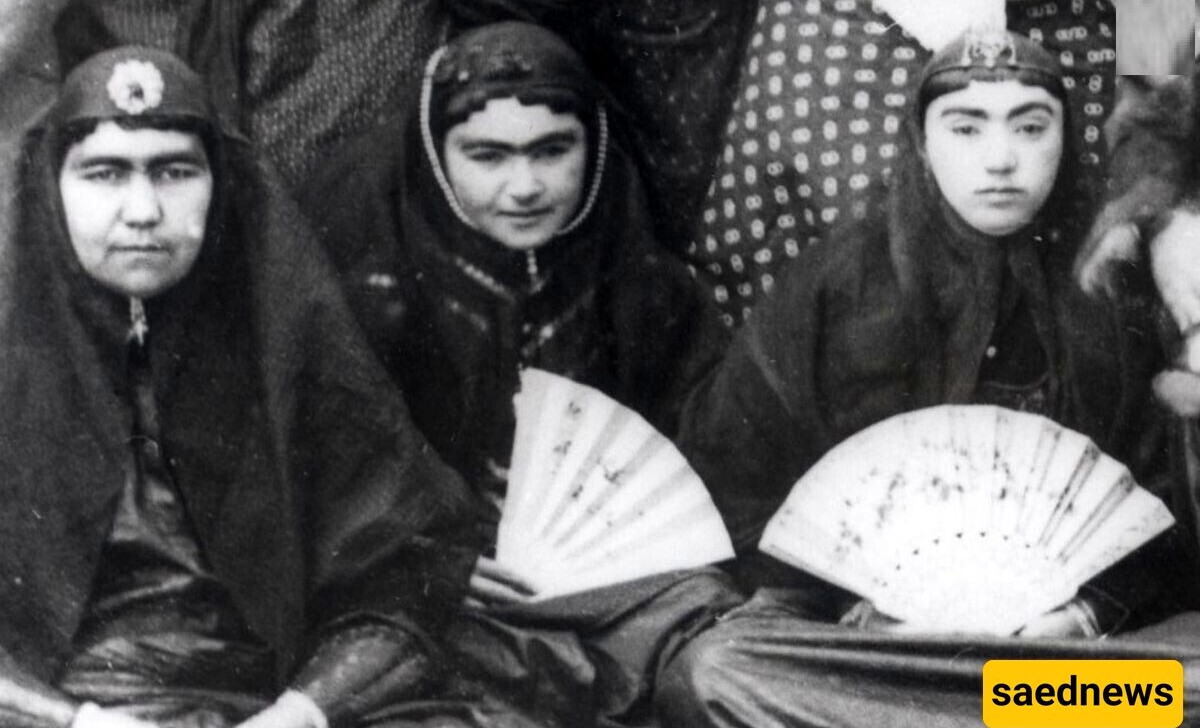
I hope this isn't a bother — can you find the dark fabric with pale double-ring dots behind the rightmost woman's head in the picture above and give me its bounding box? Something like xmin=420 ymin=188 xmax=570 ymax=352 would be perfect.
xmin=686 ymin=0 xmax=1114 ymax=325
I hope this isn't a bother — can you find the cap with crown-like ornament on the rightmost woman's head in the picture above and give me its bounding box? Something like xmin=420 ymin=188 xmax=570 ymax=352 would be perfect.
xmin=918 ymin=28 xmax=1067 ymax=116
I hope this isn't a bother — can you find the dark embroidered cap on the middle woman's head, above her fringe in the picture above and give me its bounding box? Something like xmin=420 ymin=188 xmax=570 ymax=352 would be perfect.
xmin=427 ymin=22 xmax=600 ymax=139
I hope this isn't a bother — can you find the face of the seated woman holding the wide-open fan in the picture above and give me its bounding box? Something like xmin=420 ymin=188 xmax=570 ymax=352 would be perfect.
xmin=924 ymin=80 xmax=1063 ymax=236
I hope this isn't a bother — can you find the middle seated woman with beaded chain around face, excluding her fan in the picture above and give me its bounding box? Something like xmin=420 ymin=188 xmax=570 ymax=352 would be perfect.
xmin=305 ymin=22 xmax=739 ymax=727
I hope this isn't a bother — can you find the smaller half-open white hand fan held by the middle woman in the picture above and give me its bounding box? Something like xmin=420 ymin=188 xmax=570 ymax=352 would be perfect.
xmin=496 ymin=369 xmax=733 ymax=597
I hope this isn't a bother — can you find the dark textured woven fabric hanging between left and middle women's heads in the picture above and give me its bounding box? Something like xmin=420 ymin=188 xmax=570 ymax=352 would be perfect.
xmin=245 ymin=0 xmax=443 ymax=186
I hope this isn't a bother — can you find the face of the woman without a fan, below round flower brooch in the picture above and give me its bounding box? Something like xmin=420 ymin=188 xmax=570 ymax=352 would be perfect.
xmin=59 ymin=121 xmax=212 ymax=297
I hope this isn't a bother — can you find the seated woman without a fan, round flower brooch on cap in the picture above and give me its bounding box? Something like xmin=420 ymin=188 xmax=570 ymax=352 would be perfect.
xmin=0 ymin=47 xmax=487 ymax=728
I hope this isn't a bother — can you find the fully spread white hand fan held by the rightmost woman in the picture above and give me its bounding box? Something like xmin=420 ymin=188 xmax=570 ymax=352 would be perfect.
xmin=758 ymin=405 xmax=1175 ymax=634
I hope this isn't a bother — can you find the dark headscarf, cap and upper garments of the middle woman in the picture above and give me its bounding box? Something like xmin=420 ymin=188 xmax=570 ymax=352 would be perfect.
xmin=305 ymin=22 xmax=726 ymax=503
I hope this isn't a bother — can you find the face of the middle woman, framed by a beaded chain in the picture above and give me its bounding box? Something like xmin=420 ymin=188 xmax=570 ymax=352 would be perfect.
xmin=443 ymin=97 xmax=587 ymax=251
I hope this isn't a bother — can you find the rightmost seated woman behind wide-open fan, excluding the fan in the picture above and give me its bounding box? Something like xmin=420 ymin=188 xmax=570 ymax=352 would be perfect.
xmin=660 ymin=25 xmax=1200 ymax=727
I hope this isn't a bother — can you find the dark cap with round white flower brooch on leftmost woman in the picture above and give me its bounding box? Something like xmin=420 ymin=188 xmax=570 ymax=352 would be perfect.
xmin=50 ymin=46 xmax=216 ymax=126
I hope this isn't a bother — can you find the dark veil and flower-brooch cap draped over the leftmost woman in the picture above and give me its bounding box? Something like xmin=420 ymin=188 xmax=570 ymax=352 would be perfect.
xmin=0 ymin=48 xmax=474 ymax=680
